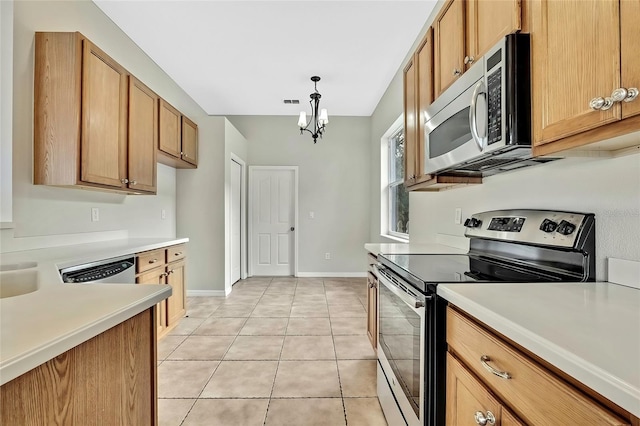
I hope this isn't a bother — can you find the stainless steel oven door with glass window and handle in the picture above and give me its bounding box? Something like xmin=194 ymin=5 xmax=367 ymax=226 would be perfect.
xmin=378 ymin=268 xmax=427 ymax=426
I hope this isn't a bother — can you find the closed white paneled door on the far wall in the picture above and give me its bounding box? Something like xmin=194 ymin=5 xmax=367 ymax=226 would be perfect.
xmin=249 ymin=167 xmax=295 ymax=275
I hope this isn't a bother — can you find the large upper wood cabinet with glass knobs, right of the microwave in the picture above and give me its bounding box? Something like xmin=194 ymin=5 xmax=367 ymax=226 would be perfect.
xmin=531 ymin=0 xmax=640 ymax=154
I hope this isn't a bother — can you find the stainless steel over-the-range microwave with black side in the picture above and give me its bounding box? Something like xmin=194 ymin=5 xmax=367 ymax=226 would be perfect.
xmin=421 ymin=34 xmax=551 ymax=176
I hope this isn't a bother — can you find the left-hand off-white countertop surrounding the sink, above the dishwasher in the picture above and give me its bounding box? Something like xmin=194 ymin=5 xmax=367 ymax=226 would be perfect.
xmin=0 ymin=238 xmax=189 ymax=385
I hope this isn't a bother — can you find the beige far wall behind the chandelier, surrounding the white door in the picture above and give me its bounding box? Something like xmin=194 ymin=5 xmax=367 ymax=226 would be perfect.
xmin=228 ymin=116 xmax=371 ymax=275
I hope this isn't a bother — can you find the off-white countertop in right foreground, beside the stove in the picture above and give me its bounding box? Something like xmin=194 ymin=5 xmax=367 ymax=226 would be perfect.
xmin=437 ymin=283 xmax=640 ymax=417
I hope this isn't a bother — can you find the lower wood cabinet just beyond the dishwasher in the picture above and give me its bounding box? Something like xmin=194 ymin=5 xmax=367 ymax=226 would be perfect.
xmin=136 ymin=244 xmax=187 ymax=338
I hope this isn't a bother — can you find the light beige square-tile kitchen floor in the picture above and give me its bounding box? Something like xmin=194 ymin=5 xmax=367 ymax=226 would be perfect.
xmin=158 ymin=277 xmax=387 ymax=426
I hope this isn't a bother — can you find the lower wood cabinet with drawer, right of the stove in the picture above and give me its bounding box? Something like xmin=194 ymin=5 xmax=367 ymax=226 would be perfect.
xmin=446 ymin=307 xmax=637 ymax=426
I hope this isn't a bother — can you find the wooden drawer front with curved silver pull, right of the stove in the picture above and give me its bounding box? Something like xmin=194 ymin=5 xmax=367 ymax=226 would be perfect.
xmin=447 ymin=308 xmax=629 ymax=425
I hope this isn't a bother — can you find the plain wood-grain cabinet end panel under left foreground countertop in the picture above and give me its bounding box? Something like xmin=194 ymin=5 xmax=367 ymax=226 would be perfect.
xmin=0 ymin=309 xmax=158 ymax=425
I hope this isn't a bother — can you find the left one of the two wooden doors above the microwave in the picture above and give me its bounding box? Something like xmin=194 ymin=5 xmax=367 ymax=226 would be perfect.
xmin=434 ymin=0 xmax=465 ymax=97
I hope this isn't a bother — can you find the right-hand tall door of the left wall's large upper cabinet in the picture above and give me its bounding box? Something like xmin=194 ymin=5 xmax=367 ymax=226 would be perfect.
xmin=127 ymin=76 xmax=158 ymax=194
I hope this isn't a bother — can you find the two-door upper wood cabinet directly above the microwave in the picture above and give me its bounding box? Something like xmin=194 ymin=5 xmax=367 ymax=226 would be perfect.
xmin=433 ymin=0 xmax=522 ymax=97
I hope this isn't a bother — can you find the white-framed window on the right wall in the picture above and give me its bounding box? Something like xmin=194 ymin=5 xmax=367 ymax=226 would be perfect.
xmin=380 ymin=116 xmax=409 ymax=241
